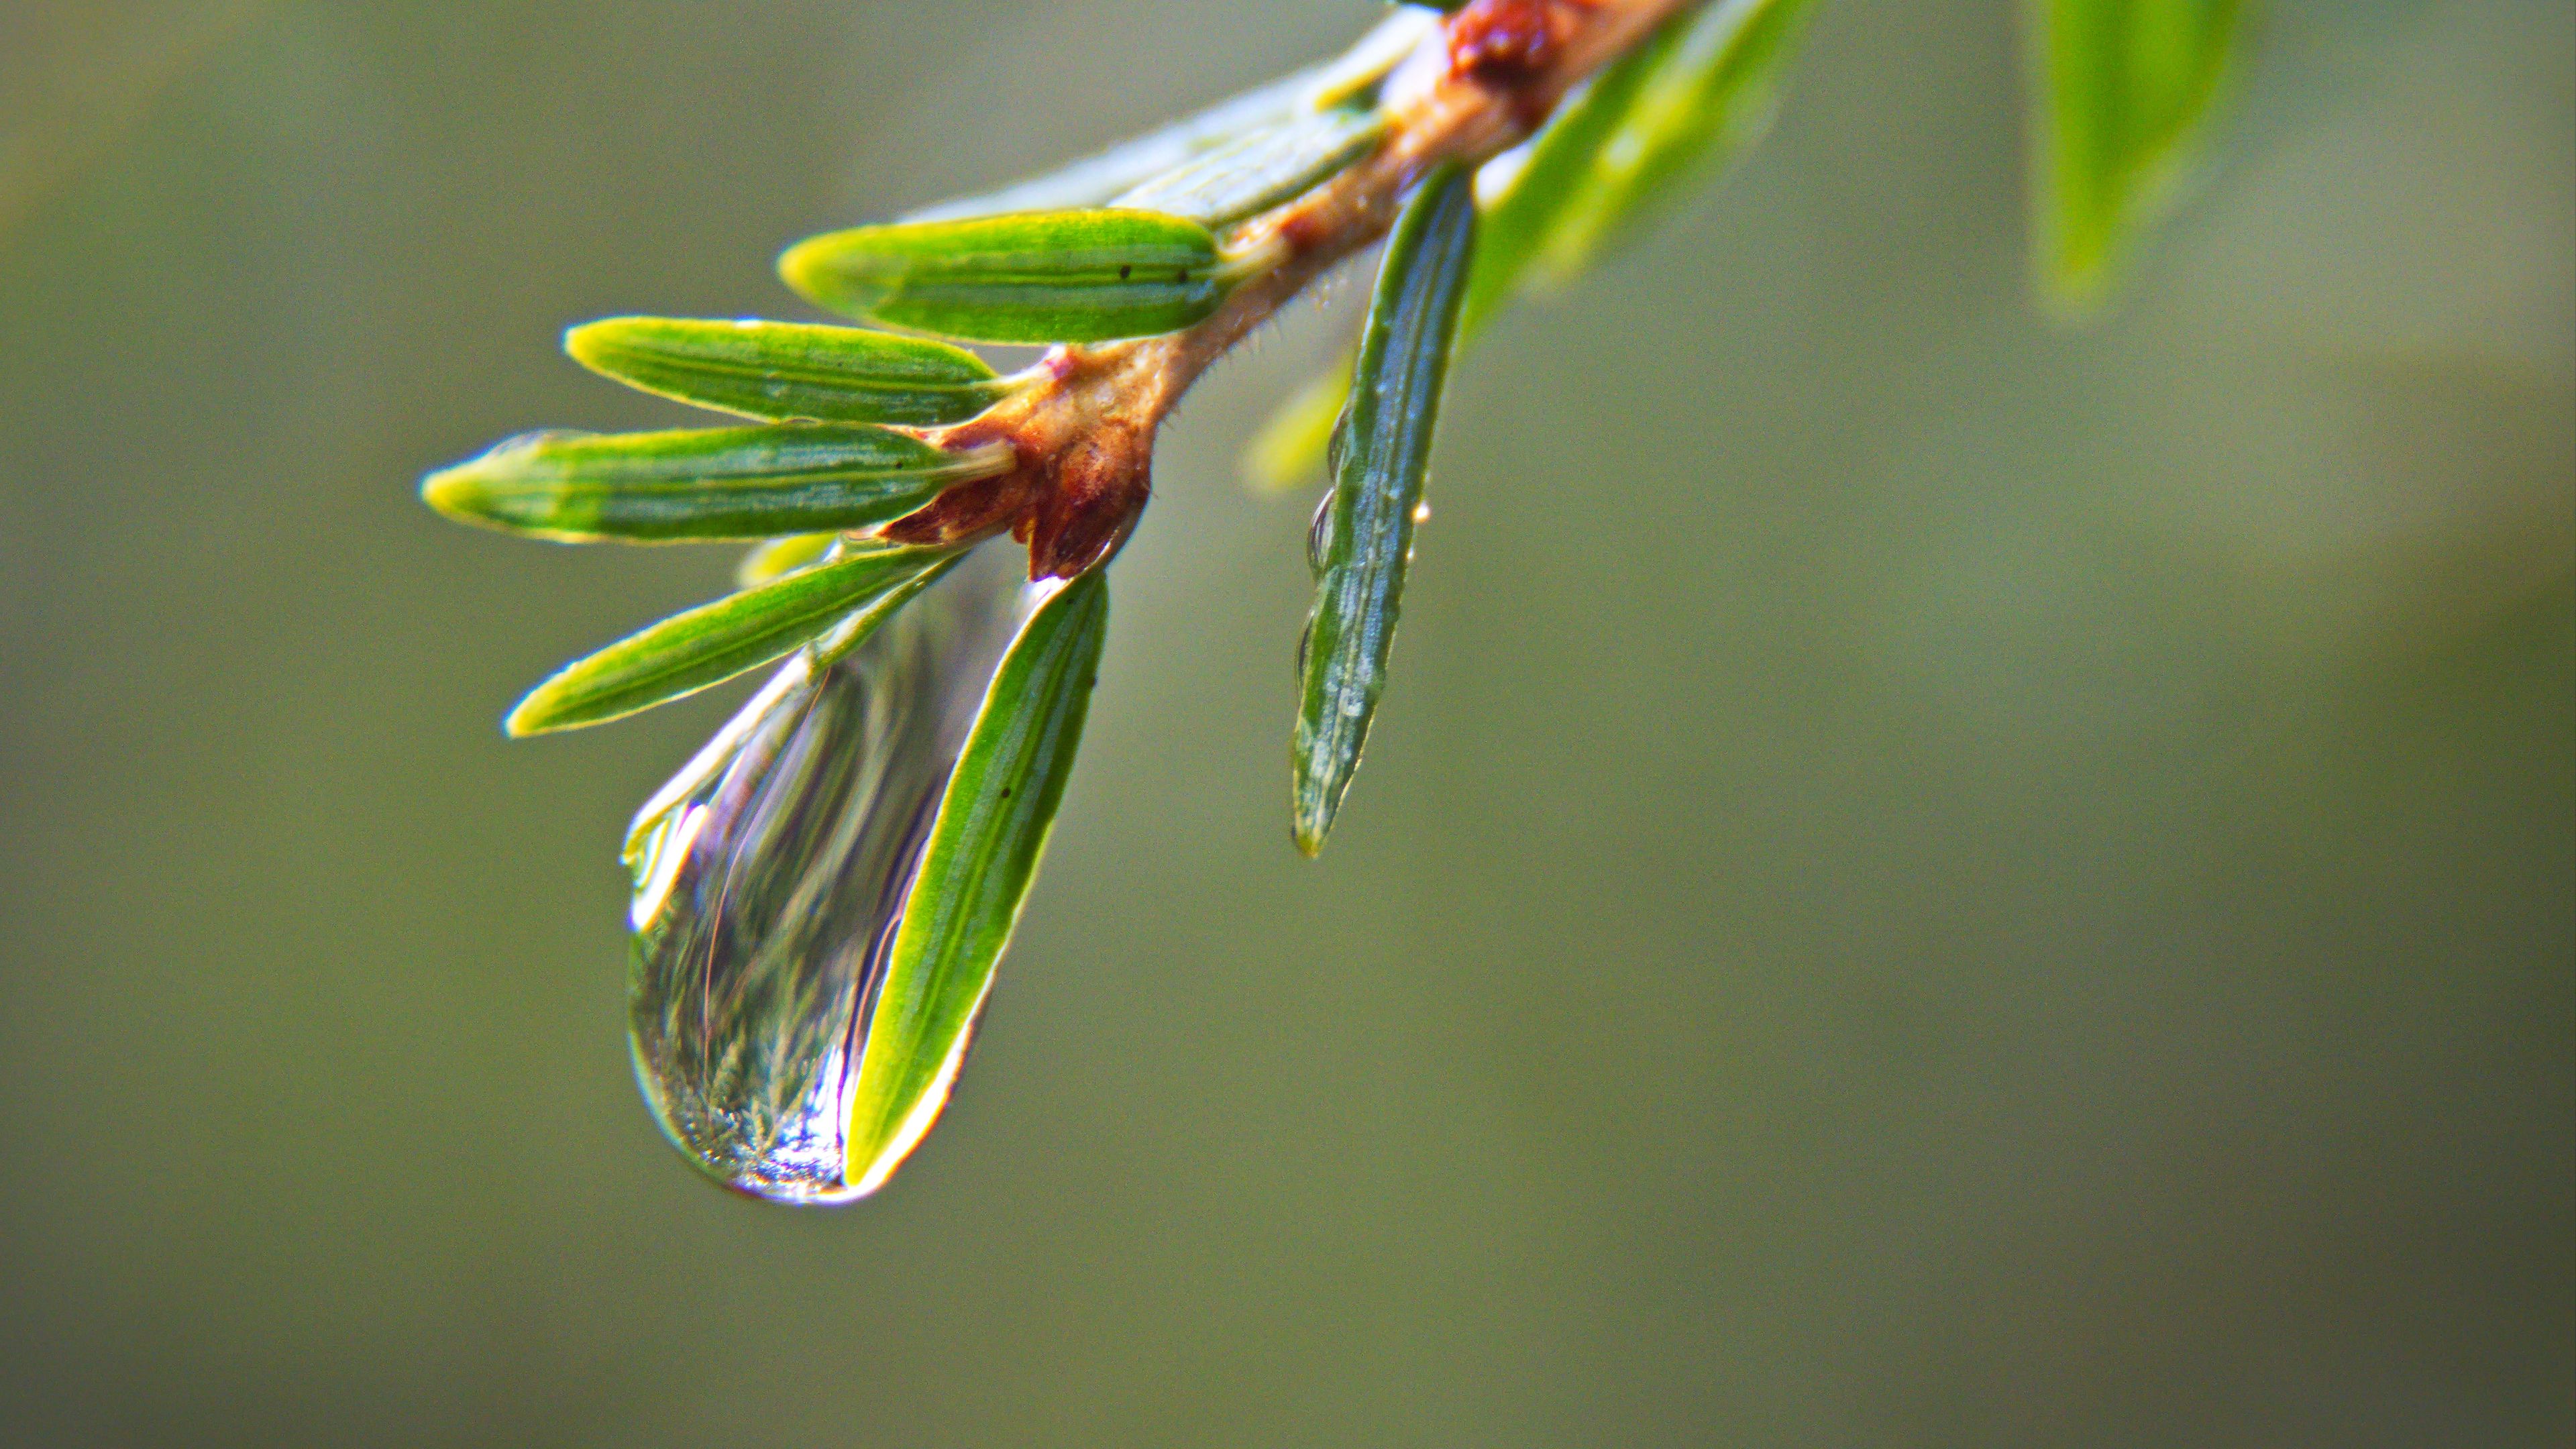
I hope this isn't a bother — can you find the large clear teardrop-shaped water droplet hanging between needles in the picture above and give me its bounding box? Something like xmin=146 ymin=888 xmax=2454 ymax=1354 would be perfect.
xmin=629 ymin=549 xmax=1049 ymax=1201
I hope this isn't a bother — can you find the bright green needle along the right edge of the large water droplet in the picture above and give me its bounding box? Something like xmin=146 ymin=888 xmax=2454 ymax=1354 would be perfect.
xmin=847 ymin=572 xmax=1108 ymax=1191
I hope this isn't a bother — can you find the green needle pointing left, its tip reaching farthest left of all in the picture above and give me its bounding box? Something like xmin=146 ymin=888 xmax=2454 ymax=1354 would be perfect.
xmin=420 ymin=423 xmax=1010 ymax=544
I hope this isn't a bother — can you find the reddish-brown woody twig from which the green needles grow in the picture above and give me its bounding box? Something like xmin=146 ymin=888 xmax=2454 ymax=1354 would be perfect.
xmin=881 ymin=0 xmax=1690 ymax=578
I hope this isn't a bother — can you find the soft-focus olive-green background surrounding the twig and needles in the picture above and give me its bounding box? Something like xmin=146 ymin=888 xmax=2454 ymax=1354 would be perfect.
xmin=0 ymin=0 xmax=2576 ymax=1446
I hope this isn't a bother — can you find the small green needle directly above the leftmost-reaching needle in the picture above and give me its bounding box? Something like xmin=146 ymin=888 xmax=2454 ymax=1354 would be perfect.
xmin=564 ymin=317 xmax=1012 ymax=428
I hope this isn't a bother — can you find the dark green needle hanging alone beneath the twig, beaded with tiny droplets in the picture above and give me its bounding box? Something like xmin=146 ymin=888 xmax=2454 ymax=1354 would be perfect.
xmin=1291 ymin=165 xmax=1476 ymax=856
